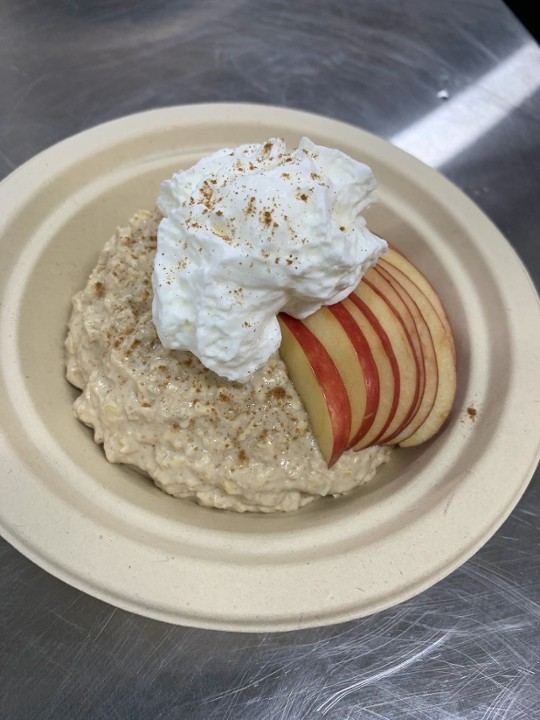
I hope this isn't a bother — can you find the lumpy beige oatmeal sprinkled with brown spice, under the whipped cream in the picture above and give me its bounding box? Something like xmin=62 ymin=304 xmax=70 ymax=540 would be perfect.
xmin=66 ymin=211 xmax=390 ymax=512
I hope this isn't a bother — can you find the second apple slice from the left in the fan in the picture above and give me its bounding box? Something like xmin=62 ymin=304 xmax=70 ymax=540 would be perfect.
xmin=302 ymin=306 xmax=376 ymax=445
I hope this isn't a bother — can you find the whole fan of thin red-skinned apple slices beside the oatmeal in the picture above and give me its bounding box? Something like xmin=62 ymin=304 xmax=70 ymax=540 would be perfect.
xmin=279 ymin=248 xmax=456 ymax=466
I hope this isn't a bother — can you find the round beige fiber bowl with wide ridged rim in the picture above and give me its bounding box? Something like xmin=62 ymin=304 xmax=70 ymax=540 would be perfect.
xmin=0 ymin=105 xmax=540 ymax=631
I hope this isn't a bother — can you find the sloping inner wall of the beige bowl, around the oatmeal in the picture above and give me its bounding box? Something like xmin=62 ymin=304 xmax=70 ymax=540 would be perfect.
xmin=15 ymin=153 xmax=467 ymax=534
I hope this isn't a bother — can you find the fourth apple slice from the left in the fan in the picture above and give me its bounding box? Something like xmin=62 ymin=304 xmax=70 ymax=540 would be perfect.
xmin=351 ymin=278 xmax=419 ymax=444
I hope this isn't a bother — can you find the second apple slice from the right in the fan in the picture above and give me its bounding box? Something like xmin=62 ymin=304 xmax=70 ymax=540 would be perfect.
xmin=373 ymin=264 xmax=439 ymax=444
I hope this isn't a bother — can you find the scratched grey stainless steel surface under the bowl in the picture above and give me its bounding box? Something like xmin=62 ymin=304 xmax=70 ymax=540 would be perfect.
xmin=0 ymin=0 xmax=540 ymax=720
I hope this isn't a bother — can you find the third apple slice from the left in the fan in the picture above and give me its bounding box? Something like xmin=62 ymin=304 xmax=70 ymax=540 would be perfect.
xmin=340 ymin=293 xmax=399 ymax=450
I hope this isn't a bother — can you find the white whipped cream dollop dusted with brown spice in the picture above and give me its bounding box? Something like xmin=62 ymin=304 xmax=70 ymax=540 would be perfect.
xmin=152 ymin=138 xmax=387 ymax=382
